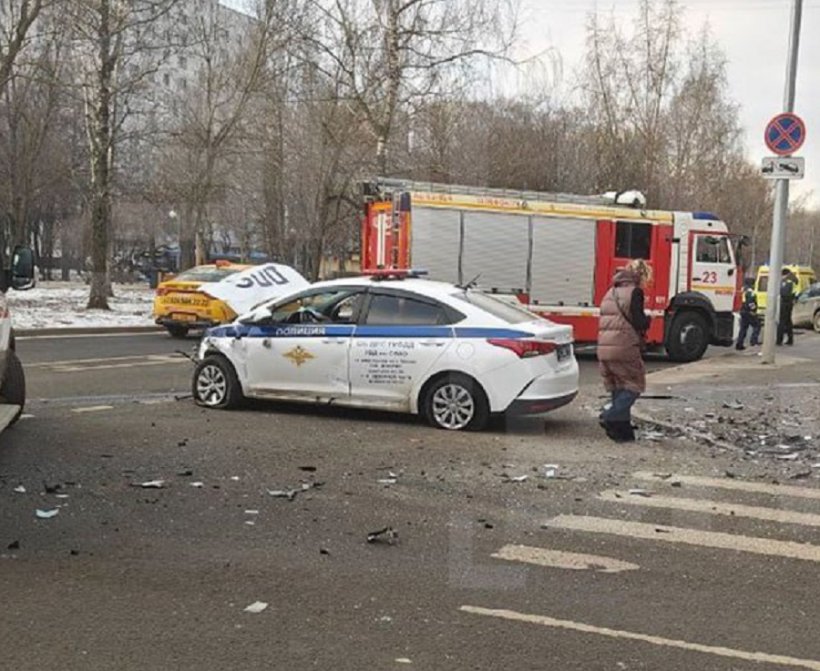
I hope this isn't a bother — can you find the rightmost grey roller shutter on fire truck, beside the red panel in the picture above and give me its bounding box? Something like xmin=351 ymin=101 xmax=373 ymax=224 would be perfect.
xmin=530 ymin=217 xmax=596 ymax=306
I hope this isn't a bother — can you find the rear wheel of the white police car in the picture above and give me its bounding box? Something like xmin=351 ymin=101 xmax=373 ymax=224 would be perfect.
xmin=421 ymin=373 xmax=490 ymax=431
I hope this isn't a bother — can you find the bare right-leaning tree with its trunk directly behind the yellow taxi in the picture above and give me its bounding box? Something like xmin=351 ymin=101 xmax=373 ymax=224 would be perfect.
xmin=152 ymin=0 xmax=293 ymax=268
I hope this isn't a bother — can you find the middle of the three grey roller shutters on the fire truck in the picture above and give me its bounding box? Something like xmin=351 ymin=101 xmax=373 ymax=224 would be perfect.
xmin=462 ymin=211 xmax=530 ymax=292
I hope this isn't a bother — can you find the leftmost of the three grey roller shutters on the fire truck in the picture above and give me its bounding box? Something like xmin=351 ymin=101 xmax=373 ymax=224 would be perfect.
xmin=410 ymin=207 xmax=462 ymax=284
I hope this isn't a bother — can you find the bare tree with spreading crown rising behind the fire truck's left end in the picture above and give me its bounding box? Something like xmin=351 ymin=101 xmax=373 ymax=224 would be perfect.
xmin=305 ymin=0 xmax=517 ymax=174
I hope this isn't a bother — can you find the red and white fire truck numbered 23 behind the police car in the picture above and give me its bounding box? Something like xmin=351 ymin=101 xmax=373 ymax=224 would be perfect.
xmin=361 ymin=179 xmax=742 ymax=361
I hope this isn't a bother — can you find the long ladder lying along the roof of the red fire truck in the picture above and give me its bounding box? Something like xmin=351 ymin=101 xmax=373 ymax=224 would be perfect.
xmin=362 ymin=177 xmax=646 ymax=208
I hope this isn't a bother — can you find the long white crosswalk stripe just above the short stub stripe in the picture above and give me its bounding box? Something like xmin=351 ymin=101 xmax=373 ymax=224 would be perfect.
xmin=548 ymin=515 xmax=820 ymax=562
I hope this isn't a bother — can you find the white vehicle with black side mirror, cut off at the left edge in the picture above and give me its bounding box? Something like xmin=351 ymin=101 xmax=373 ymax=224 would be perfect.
xmin=0 ymin=247 xmax=34 ymax=431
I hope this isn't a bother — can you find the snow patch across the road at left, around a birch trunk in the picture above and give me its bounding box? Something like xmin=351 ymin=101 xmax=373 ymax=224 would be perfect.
xmin=6 ymin=282 xmax=154 ymax=330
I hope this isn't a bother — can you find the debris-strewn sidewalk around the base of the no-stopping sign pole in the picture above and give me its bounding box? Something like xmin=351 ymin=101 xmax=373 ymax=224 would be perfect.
xmin=634 ymin=331 xmax=820 ymax=478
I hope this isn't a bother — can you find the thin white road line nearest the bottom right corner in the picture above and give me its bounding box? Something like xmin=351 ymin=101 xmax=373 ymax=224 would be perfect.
xmin=459 ymin=606 xmax=820 ymax=671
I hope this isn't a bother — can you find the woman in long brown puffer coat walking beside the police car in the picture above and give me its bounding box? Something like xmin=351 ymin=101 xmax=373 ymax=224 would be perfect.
xmin=598 ymin=259 xmax=652 ymax=442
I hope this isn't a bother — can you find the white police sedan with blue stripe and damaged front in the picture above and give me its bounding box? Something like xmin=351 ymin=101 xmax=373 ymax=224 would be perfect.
xmin=192 ymin=275 xmax=578 ymax=429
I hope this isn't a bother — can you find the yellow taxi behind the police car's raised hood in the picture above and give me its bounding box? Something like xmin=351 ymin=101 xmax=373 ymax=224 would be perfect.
xmin=154 ymin=261 xmax=251 ymax=338
